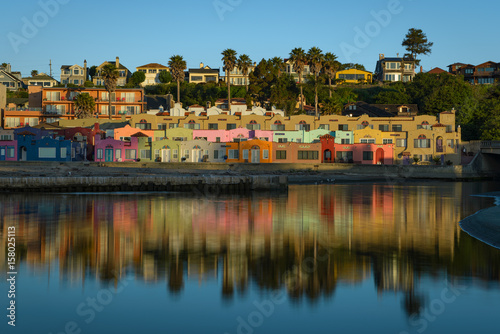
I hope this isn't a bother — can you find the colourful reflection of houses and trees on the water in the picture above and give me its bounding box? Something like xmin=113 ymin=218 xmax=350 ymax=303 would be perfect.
xmin=0 ymin=183 xmax=500 ymax=315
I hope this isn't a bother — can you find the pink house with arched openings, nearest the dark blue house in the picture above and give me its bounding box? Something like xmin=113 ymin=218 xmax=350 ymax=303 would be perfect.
xmin=94 ymin=135 xmax=138 ymax=162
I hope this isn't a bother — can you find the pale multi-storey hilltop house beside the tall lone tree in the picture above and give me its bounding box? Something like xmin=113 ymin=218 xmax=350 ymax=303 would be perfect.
xmin=373 ymin=54 xmax=415 ymax=82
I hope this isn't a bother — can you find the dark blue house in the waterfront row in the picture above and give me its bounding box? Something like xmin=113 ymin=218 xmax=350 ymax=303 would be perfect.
xmin=17 ymin=131 xmax=72 ymax=161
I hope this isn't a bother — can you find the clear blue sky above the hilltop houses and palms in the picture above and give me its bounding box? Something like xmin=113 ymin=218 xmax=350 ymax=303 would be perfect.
xmin=0 ymin=0 xmax=500 ymax=80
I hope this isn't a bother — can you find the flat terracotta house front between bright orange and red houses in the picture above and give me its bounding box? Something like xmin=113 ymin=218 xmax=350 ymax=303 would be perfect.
xmin=273 ymin=143 xmax=321 ymax=163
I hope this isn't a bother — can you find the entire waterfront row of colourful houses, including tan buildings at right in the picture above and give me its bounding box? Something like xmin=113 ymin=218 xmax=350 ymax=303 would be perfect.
xmin=0 ymin=113 xmax=460 ymax=164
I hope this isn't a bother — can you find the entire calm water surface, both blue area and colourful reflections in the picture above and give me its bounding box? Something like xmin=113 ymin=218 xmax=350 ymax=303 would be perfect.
xmin=0 ymin=182 xmax=500 ymax=334
